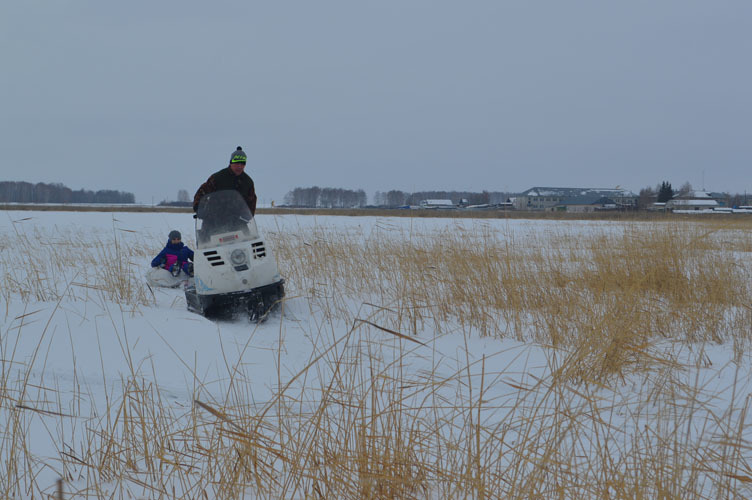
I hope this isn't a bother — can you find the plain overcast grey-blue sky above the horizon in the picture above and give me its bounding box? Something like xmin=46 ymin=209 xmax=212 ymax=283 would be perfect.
xmin=0 ymin=0 xmax=752 ymax=203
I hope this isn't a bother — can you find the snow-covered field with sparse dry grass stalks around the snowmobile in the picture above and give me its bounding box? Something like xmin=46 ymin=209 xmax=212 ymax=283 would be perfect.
xmin=0 ymin=211 xmax=752 ymax=498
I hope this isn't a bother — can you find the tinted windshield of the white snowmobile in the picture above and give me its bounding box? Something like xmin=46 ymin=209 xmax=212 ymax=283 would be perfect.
xmin=196 ymin=189 xmax=259 ymax=248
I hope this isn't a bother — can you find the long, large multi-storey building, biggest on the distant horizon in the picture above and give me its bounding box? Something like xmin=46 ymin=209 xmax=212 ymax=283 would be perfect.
xmin=514 ymin=187 xmax=638 ymax=211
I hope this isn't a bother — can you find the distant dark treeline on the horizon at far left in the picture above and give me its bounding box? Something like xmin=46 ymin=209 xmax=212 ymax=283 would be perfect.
xmin=0 ymin=181 xmax=136 ymax=203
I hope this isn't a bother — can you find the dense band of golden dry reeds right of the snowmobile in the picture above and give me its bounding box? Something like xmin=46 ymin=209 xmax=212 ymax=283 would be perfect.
xmin=274 ymin=219 xmax=752 ymax=373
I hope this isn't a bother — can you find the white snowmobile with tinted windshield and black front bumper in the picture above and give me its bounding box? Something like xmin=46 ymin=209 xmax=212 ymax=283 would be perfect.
xmin=185 ymin=190 xmax=285 ymax=321
